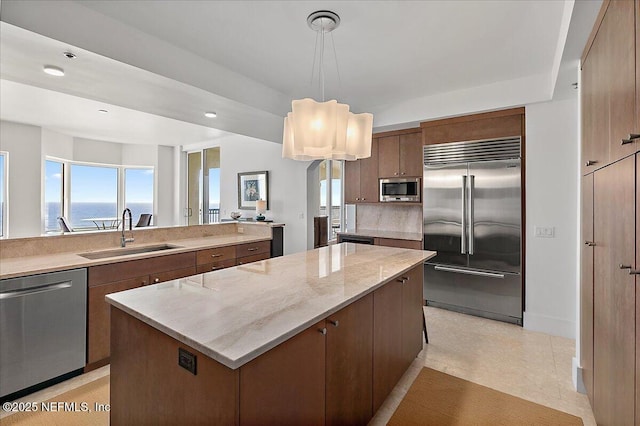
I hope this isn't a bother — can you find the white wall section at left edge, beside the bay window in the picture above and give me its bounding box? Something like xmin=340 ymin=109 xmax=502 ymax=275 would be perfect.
xmin=0 ymin=121 xmax=42 ymax=238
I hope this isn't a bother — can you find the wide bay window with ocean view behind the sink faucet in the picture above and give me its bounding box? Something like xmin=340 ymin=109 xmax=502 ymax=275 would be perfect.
xmin=44 ymin=158 xmax=154 ymax=232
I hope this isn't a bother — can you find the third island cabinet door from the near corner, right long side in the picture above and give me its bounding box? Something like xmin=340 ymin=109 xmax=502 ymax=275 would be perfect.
xmin=373 ymin=280 xmax=405 ymax=413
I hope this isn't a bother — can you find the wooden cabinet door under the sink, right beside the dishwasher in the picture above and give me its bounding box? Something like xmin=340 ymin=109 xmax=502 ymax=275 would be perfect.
xmin=87 ymin=275 xmax=149 ymax=364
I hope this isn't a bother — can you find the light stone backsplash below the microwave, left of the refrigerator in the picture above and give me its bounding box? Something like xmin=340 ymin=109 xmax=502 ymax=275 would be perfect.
xmin=356 ymin=204 xmax=422 ymax=233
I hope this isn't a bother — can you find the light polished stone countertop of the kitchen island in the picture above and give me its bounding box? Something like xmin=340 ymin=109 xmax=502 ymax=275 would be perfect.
xmin=106 ymin=243 xmax=436 ymax=369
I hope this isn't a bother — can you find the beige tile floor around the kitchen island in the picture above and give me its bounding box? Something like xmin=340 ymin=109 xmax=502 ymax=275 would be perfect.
xmin=0 ymin=307 xmax=596 ymax=426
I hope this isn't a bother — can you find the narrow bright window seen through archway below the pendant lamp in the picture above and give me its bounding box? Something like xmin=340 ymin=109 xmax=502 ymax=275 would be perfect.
xmin=320 ymin=160 xmax=343 ymax=240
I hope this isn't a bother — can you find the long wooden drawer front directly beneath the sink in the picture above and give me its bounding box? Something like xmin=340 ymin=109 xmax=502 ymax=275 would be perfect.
xmin=88 ymin=252 xmax=196 ymax=287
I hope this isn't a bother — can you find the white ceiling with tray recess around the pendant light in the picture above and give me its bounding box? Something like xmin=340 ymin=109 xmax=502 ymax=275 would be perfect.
xmin=0 ymin=0 xmax=601 ymax=145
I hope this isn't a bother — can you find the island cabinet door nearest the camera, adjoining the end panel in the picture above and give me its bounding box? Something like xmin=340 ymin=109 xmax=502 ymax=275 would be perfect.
xmin=240 ymin=320 xmax=325 ymax=425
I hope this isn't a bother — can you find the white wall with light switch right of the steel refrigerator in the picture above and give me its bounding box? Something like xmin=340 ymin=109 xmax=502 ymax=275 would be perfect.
xmin=524 ymin=97 xmax=579 ymax=338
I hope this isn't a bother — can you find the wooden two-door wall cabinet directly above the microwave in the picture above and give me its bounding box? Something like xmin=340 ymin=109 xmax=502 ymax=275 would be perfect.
xmin=378 ymin=129 xmax=422 ymax=178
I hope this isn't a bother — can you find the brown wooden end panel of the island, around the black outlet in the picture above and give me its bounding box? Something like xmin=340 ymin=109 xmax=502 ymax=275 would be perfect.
xmin=110 ymin=307 xmax=239 ymax=426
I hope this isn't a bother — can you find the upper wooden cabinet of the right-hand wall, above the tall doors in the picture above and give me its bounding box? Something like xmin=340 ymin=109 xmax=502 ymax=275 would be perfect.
xmin=582 ymin=0 xmax=640 ymax=174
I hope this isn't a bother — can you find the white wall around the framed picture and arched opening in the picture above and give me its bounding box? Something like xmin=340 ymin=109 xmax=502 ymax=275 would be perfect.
xmin=208 ymin=135 xmax=313 ymax=254
